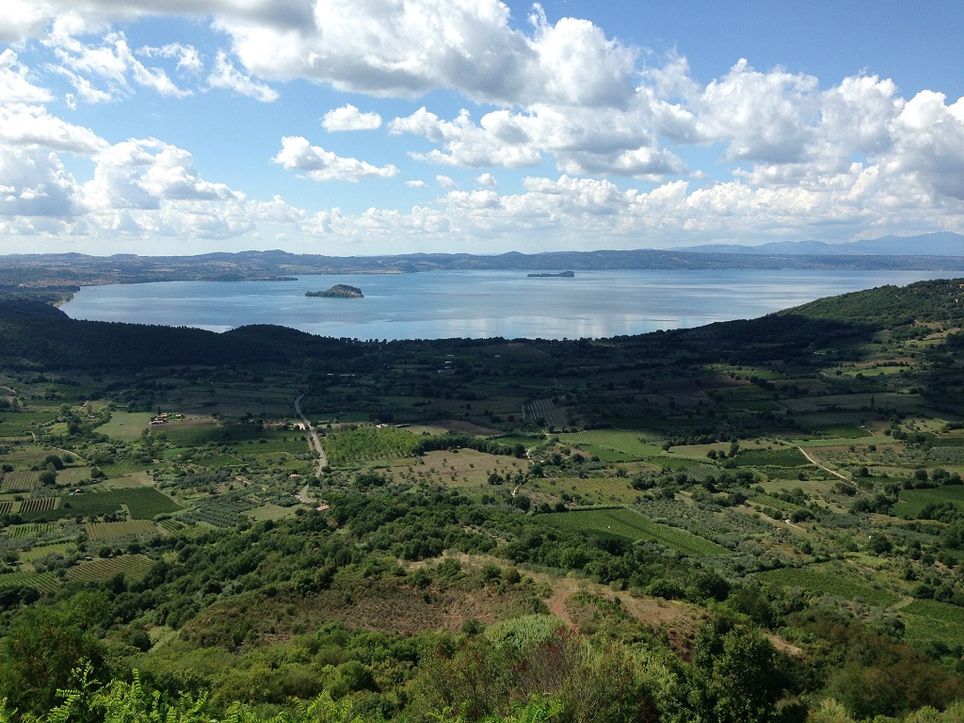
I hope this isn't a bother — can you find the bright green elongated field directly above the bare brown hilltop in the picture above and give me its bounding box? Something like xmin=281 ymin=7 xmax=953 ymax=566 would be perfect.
xmin=539 ymin=507 xmax=728 ymax=556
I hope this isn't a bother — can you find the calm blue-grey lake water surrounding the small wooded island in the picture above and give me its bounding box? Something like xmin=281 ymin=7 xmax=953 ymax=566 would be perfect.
xmin=62 ymin=270 xmax=946 ymax=339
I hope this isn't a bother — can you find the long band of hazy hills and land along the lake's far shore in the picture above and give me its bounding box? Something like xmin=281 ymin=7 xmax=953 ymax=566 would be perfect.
xmin=0 ymin=232 xmax=964 ymax=292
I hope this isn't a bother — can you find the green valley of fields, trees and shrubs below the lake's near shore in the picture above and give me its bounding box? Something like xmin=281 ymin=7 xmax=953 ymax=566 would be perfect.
xmin=0 ymin=281 xmax=964 ymax=722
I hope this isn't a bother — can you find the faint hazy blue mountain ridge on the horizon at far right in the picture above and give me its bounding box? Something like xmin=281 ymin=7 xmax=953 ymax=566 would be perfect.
xmin=677 ymin=231 xmax=964 ymax=256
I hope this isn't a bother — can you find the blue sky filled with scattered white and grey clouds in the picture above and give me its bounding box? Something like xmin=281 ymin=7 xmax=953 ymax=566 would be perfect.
xmin=0 ymin=0 xmax=964 ymax=256
